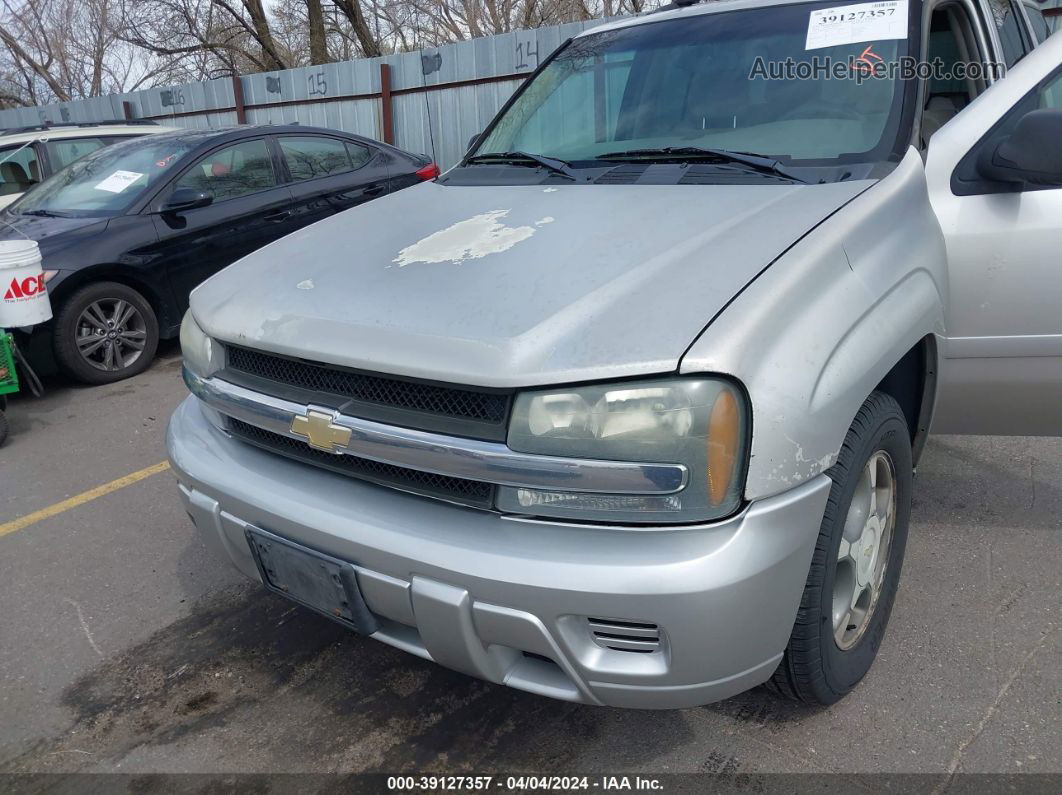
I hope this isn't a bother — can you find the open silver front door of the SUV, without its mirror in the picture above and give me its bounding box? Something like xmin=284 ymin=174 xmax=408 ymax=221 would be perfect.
xmin=926 ymin=36 xmax=1062 ymax=435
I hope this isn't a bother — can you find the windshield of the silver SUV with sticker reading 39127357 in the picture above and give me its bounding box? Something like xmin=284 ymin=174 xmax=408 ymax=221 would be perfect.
xmin=475 ymin=0 xmax=908 ymax=166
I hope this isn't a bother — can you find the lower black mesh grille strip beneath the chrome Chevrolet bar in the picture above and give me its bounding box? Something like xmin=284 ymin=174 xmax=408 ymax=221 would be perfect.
xmin=228 ymin=417 xmax=494 ymax=508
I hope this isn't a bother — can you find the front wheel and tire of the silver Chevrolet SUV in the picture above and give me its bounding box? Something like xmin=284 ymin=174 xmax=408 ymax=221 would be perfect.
xmin=767 ymin=392 xmax=913 ymax=705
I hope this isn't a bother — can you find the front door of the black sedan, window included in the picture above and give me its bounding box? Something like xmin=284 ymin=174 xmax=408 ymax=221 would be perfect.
xmin=154 ymin=138 xmax=291 ymax=312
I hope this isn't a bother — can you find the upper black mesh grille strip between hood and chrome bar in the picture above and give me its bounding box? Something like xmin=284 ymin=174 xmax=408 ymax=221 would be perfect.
xmin=226 ymin=346 xmax=509 ymax=425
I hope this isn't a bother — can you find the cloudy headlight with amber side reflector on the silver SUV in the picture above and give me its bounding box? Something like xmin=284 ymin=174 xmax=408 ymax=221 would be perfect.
xmin=497 ymin=378 xmax=749 ymax=523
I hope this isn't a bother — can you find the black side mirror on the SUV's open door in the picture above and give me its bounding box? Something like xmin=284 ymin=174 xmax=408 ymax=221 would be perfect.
xmin=977 ymin=108 xmax=1062 ymax=186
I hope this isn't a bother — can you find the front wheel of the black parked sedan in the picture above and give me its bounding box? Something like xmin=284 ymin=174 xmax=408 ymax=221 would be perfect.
xmin=52 ymin=281 xmax=158 ymax=384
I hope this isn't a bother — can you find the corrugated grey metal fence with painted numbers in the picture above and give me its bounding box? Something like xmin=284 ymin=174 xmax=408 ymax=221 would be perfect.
xmin=0 ymin=20 xmax=602 ymax=168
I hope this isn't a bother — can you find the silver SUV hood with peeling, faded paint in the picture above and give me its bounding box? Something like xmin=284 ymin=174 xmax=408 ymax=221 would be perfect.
xmin=191 ymin=182 xmax=872 ymax=386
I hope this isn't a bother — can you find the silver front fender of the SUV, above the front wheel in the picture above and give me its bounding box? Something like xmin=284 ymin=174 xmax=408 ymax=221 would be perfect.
xmin=681 ymin=149 xmax=947 ymax=500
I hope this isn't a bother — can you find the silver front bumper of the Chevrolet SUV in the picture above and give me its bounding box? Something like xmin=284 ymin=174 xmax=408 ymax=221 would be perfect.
xmin=167 ymin=397 xmax=829 ymax=708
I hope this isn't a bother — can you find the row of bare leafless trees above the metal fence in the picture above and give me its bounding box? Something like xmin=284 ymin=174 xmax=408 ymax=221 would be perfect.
xmin=0 ymin=0 xmax=663 ymax=106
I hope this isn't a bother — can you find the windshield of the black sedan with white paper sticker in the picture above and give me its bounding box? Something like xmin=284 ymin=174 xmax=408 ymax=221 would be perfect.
xmin=11 ymin=136 xmax=196 ymax=217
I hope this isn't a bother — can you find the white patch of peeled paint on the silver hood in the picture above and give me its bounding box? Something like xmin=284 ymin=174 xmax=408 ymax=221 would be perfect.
xmin=392 ymin=210 xmax=553 ymax=267
